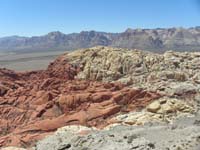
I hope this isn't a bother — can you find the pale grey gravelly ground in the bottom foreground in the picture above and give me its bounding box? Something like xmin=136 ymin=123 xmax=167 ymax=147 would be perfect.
xmin=34 ymin=114 xmax=200 ymax=150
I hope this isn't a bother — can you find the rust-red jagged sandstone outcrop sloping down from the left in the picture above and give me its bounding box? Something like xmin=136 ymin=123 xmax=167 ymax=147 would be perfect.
xmin=0 ymin=55 xmax=160 ymax=147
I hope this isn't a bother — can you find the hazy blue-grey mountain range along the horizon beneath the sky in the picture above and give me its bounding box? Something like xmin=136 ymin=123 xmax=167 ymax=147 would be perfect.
xmin=0 ymin=26 xmax=200 ymax=52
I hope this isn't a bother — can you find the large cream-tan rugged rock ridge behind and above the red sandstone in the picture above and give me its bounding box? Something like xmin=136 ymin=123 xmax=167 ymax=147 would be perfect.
xmin=58 ymin=47 xmax=200 ymax=94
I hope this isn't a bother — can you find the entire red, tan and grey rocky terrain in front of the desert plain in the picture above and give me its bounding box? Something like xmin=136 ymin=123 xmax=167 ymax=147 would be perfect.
xmin=0 ymin=47 xmax=200 ymax=150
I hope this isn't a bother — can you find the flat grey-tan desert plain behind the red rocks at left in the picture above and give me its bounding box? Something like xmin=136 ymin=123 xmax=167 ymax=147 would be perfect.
xmin=0 ymin=51 xmax=66 ymax=71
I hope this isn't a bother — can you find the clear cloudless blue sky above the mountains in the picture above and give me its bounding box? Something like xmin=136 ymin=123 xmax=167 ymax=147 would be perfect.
xmin=0 ymin=0 xmax=200 ymax=37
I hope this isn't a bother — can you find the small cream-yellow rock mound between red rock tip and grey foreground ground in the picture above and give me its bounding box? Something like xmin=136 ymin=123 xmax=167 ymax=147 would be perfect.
xmin=115 ymin=97 xmax=196 ymax=125
